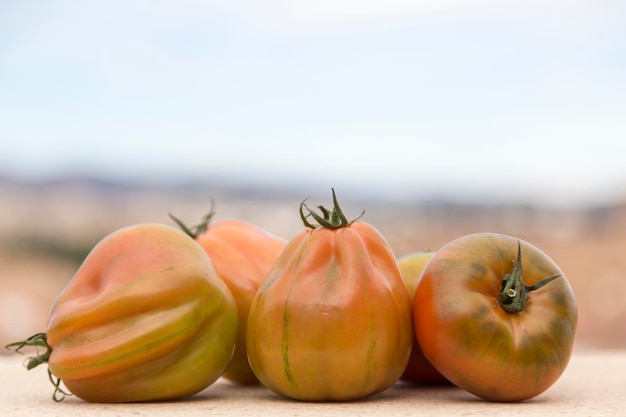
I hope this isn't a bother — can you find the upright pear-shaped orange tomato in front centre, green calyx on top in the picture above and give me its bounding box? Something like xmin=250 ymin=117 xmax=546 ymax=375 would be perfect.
xmin=248 ymin=190 xmax=413 ymax=401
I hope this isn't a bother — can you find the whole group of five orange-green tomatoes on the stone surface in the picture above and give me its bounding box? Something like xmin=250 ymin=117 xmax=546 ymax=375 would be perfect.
xmin=8 ymin=191 xmax=577 ymax=402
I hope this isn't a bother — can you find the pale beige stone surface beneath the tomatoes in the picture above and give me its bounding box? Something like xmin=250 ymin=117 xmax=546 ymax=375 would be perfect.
xmin=0 ymin=350 xmax=626 ymax=417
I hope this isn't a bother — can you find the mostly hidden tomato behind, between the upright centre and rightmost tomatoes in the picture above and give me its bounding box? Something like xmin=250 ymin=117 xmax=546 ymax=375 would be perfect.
xmin=398 ymin=250 xmax=449 ymax=385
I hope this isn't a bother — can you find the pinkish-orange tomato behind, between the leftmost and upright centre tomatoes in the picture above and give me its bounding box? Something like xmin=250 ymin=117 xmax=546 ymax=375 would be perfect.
xmin=170 ymin=210 xmax=287 ymax=384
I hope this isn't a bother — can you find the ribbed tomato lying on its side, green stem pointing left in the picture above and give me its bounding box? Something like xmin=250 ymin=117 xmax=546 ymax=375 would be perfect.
xmin=6 ymin=224 xmax=238 ymax=402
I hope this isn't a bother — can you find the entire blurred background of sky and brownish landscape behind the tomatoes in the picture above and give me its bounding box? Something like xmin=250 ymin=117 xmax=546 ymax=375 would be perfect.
xmin=0 ymin=0 xmax=626 ymax=349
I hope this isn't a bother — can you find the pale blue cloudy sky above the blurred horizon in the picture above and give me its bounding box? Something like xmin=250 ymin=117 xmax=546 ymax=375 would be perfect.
xmin=0 ymin=0 xmax=626 ymax=204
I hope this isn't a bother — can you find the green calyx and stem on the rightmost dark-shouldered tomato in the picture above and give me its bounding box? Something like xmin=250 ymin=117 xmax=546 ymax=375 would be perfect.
xmin=496 ymin=241 xmax=560 ymax=314
